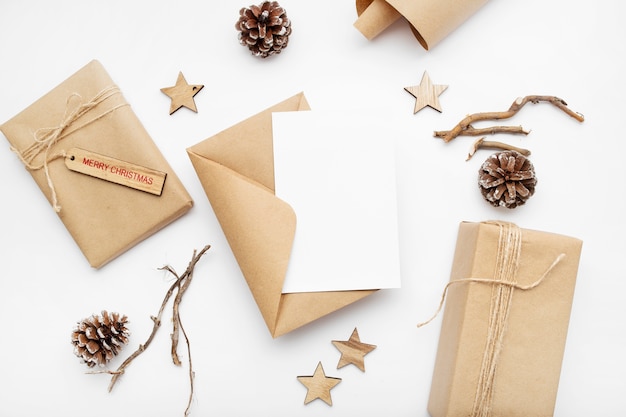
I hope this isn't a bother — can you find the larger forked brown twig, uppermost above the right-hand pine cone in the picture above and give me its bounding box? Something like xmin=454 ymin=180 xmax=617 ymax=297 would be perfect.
xmin=434 ymin=95 xmax=585 ymax=142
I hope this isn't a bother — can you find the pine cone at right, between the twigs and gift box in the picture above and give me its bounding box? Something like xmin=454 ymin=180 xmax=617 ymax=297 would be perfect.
xmin=478 ymin=151 xmax=537 ymax=209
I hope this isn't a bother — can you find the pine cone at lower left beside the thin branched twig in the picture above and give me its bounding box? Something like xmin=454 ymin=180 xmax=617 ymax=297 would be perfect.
xmin=72 ymin=311 xmax=130 ymax=368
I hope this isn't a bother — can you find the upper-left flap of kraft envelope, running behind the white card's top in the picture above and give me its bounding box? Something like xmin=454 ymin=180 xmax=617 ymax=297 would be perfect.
xmin=189 ymin=92 xmax=310 ymax=190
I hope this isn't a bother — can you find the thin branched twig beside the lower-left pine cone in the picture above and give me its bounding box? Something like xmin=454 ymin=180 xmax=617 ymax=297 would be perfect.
xmin=103 ymin=245 xmax=211 ymax=415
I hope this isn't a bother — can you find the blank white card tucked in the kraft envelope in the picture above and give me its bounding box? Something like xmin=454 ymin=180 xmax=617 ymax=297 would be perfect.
xmin=272 ymin=110 xmax=401 ymax=293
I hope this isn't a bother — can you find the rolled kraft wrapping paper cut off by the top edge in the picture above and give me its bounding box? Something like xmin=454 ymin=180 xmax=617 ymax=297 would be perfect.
xmin=354 ymin=0 xmax=489 ymax=50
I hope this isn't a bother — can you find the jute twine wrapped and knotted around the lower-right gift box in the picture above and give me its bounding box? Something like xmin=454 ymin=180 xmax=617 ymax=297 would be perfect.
xmin=417 ymin=222 xmax=565 ymax=417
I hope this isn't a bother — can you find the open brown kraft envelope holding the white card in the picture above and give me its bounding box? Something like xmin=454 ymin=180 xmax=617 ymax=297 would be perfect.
xmin=187 ymin=93 xmax=377 ymax=337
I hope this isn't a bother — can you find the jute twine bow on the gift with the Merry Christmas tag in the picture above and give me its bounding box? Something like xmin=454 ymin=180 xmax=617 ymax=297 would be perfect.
xmin=11 ymin=85 xmax=128 ymax=213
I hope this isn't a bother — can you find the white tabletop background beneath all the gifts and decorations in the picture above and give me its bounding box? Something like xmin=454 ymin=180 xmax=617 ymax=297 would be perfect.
xmin=0 ymin=0 xmax=626 ymax=417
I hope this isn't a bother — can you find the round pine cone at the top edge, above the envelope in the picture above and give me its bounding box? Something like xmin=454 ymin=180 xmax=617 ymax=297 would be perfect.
xmin=235 ymin=1 xmax=291 ymax=58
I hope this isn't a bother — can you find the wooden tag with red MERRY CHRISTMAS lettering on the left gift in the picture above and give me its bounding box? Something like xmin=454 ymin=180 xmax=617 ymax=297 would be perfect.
xmin=65 ymin=148 xmax=167 ymax=196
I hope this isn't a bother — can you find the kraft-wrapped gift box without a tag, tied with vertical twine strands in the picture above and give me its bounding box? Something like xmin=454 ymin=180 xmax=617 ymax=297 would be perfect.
xmin=428 ymin=222 xmax=582 ymax=417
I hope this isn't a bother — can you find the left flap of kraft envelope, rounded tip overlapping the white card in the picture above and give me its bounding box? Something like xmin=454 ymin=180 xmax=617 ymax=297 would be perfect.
xmin=188 ymin=150 xmax=296 ymax=333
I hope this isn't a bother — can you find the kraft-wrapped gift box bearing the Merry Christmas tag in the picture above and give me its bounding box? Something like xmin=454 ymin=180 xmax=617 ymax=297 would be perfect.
xmin=0 ymin=60 xmax=193 ymax=268
